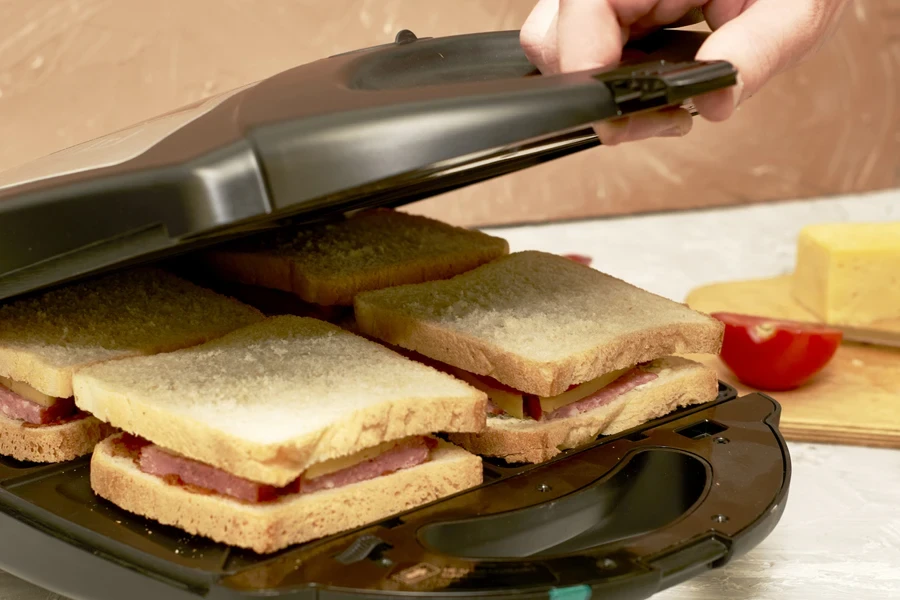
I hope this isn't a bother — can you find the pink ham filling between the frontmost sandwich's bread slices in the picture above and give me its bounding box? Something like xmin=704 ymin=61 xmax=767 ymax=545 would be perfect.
xmin=131 ymin=437 xmax=436 ymax=502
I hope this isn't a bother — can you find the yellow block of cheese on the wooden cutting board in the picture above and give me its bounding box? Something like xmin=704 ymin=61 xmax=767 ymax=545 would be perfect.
xmin=792 ymin=222 xmax=900 ymax=326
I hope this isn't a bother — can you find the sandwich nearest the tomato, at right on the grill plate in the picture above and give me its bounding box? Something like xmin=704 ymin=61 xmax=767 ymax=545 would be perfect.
xmin=354 ymin=252 xmax=724 ymax=463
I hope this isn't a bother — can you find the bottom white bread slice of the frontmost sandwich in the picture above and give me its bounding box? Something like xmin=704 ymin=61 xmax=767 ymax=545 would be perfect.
xmin=91 ymin=437 xmax=483 ymax=553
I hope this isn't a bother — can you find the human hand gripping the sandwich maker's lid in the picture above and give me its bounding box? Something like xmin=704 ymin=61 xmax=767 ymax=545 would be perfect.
xmin=520 ymin=0 xmax=847 ymax=145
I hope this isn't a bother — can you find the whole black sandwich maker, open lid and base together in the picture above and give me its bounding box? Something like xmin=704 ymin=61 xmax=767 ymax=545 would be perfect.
xmin=0 ymin=30 xmax=790 ymax=600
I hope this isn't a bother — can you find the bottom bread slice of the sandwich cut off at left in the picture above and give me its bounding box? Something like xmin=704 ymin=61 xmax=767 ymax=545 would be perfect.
xmin=0 ymin=415 xmax=115 ymax=463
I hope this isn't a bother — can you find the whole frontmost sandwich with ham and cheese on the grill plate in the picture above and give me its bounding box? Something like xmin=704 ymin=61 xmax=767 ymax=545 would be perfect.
xmin=74 ymin=315 xmax=487 ymax=553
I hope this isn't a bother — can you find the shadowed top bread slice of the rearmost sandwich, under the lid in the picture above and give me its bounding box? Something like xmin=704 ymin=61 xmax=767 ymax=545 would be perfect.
xmin=202 ymin=210 xmax=509 ymax=306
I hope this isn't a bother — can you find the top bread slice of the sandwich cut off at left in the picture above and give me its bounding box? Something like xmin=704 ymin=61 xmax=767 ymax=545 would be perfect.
xmin=0 ymin=268 xmax=263 ymax=398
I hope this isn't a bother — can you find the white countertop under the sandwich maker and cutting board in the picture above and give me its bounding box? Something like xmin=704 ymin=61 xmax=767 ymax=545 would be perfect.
xmin=0 ymin=190 xmax=900 ymax=600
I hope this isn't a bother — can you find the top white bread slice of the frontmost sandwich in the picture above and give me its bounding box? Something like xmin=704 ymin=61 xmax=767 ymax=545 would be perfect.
xmin=74 ymin=316 xmax=487 ymax=486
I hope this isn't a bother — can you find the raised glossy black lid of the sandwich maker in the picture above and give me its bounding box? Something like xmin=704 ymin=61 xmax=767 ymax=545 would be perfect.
xmin=0 ymin=31 xmax=736 ymax=300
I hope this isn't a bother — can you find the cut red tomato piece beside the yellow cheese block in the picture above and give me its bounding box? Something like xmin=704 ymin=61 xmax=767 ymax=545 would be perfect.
xmin=712 ymin=312 xmax=843 ymax=391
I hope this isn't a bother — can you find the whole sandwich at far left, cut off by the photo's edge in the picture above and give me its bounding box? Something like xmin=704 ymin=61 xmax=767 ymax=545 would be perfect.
xmin=0 ymin=269 xmax=263 ymax=463
